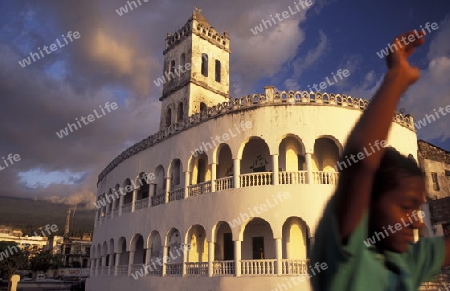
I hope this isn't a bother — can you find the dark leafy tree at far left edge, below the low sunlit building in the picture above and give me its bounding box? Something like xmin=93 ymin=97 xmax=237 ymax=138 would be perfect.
xmin=0 ymin=241 xmax=28 ymax=280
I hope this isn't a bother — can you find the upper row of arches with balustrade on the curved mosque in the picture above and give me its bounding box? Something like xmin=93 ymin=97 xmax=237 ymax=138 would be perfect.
xmin=96 ymin=133 xmax=342 ymax=226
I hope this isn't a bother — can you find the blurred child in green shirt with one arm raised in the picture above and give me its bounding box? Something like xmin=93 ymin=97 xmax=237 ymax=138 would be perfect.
xmin=310 ymin=33 xmax=450 ymax=291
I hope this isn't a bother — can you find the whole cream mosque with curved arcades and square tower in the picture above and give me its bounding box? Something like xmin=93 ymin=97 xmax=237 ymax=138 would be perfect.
xmin=86 ymin=10 xmax=418 ymax=291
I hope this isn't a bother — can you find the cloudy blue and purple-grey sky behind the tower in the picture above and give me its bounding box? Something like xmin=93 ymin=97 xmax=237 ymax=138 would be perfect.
xmin=0 ymin=0 xmax=450 ymax=210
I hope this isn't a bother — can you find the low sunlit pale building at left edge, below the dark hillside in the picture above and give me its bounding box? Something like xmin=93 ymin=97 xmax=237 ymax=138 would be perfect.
xmin=0 ymin=225 xmax=48 ymax=251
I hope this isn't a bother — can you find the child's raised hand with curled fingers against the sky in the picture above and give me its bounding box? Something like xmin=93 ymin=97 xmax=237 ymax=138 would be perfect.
xmin=386 ymin=31 xmax=425 ymax=86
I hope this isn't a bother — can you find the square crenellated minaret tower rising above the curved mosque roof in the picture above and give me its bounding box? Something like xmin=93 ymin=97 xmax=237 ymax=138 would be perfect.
xmin=159 ymin=7 xmax=230 ymax=130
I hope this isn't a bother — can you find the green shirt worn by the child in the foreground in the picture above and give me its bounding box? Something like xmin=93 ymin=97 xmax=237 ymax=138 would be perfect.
xmin=310 ymin=196 xmax=445 ymax=291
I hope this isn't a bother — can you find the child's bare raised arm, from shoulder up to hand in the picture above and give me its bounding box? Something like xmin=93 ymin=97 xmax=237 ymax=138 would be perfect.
xmin=336 ymin=32 xmax=424 ymax=239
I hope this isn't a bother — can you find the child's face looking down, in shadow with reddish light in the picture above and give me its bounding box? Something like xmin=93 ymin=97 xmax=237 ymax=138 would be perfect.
xmin=369 ymin=176 xmax=426 ymax=253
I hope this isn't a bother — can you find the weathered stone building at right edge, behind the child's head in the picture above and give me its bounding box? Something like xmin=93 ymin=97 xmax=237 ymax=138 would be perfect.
xmin=418 ymin=140 xmax=450 ymax=236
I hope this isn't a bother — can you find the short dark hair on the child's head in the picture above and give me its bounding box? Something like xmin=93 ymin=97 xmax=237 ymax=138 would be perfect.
xmin=371 ymin=147 xmax=424 ymax=201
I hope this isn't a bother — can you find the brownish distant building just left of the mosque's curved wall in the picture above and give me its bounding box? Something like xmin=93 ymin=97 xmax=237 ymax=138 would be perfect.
xmin=50 ymin=233 xmax=92 ymax=268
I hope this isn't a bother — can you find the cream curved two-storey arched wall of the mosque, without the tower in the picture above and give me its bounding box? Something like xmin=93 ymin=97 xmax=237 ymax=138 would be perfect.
xmin=87 ymin=92 xmax=417 ymax=290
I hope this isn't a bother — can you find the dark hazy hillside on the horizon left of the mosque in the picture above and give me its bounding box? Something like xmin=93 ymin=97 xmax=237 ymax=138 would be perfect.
xmin=0 ymin=196 xmax=95 ymax=234
